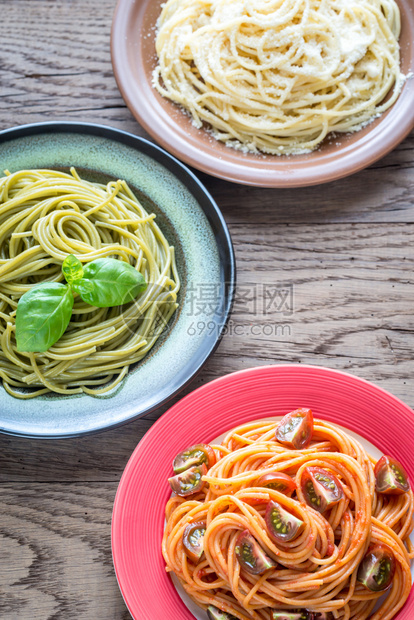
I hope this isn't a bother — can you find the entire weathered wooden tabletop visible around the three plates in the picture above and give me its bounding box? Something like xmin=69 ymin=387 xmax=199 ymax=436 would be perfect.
xmin=0 ymin=0 xmax=414 ymax=620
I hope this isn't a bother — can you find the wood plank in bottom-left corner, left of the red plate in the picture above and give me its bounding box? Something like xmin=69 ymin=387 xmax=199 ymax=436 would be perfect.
xmin=0 ymin=483 xmax=131 ymax=620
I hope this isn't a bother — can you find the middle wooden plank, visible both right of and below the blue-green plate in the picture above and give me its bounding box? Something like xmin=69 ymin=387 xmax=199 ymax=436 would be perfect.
xmin=0 ymin=224 xmax=414 ymax=482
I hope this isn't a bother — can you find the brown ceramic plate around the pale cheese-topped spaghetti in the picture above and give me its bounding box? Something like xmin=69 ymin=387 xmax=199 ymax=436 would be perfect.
xmin=111 ymin=0 xmax=414 ymax=187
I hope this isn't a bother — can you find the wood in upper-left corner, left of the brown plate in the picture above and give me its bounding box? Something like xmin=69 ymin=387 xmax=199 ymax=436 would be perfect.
xmin=0 ymin=0 xmax=129 ymax=129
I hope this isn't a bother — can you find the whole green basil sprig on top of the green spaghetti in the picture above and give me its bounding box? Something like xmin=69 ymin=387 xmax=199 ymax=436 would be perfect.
xmin=16 ymin=254 xmax=147 ymax=353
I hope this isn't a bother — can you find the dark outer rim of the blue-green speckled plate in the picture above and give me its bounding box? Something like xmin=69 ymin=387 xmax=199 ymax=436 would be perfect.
xmin=0 ymin=121 xmax=236 ymax=439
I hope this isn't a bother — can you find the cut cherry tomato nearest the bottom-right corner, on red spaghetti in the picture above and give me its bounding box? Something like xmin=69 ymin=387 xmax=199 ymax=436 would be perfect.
xmin=357 ymin=544 xmax=395 ymax=592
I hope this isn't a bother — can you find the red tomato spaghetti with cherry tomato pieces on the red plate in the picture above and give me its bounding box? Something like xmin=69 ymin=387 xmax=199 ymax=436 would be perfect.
xmin=162 ymin=409 xmax=414 ymax=620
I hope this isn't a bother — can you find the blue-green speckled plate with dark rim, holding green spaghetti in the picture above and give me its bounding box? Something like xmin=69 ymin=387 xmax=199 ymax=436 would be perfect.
xmin=0 ymin=122 xmax=235 ymax=438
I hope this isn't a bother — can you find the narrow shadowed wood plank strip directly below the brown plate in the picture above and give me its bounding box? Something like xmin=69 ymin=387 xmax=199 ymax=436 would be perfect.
xmin=197 ymin=151 xmax=414 ymax=226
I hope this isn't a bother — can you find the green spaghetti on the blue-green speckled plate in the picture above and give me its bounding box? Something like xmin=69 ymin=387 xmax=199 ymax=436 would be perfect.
xmin=0 ymin=168 xmax=180 ymax=398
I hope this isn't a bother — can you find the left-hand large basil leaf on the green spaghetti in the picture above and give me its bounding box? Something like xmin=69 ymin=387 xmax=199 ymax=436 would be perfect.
xmin=16 ymin=282 xmax=73 ymax=353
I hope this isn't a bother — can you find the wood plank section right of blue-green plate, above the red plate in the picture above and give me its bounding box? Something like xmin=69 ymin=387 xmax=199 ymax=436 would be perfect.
xmin=212 ymin=224 xmax=414 ymax=394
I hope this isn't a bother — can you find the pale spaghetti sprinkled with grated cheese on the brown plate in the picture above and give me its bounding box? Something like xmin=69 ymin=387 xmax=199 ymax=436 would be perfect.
xmin=153 ymin=0 xmax=405 ymax=155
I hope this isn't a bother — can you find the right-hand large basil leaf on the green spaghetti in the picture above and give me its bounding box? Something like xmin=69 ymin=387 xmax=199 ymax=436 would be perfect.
xmin=72 ymin=258 xmax=147 ymax=308
